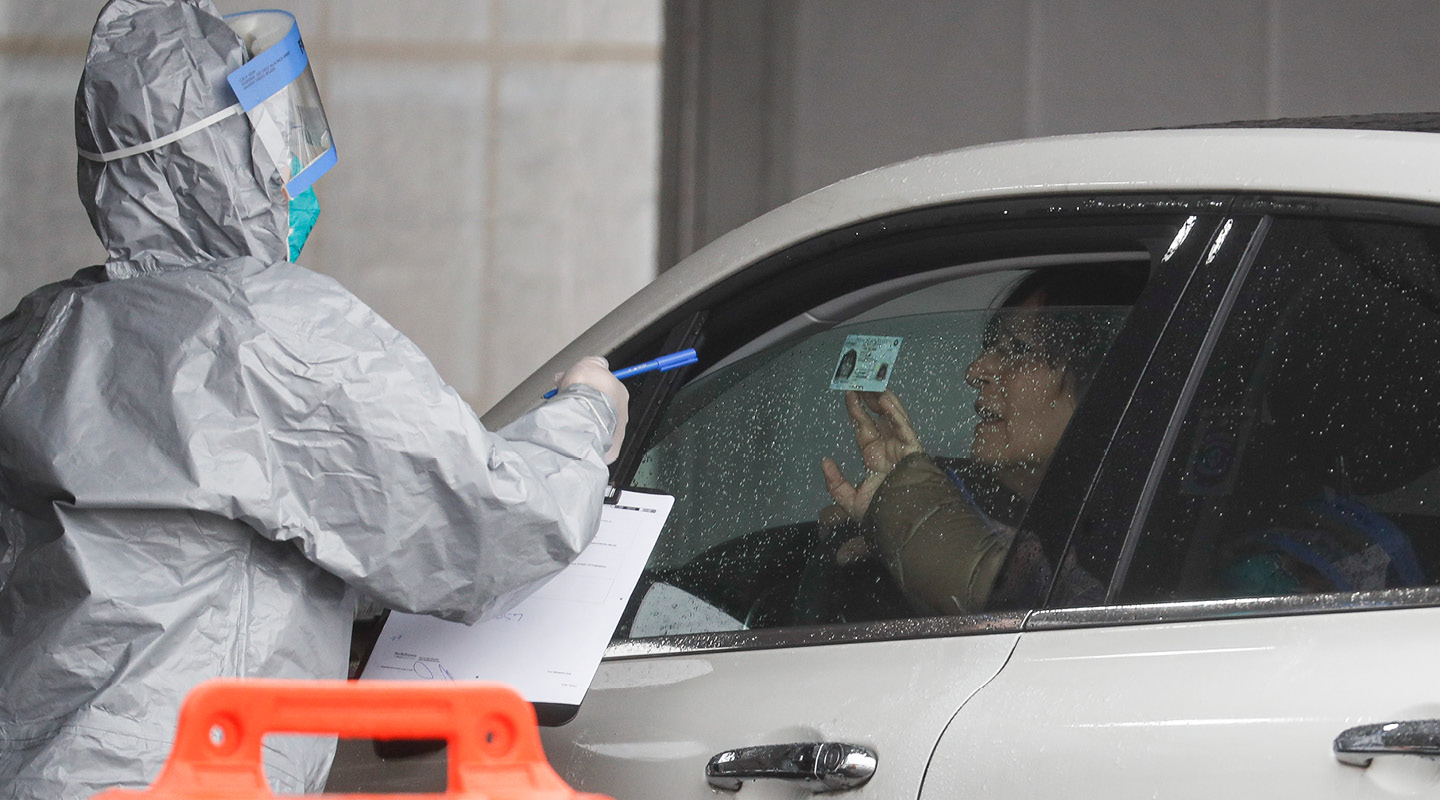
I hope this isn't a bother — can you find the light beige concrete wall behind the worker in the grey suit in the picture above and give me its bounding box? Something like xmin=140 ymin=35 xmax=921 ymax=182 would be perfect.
xmin=0 ymin=0 xmax=662 ymax=410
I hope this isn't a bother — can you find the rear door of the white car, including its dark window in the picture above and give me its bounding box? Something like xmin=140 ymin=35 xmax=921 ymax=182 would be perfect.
xmin=922 ymin=197 xmax=1440 ymax=799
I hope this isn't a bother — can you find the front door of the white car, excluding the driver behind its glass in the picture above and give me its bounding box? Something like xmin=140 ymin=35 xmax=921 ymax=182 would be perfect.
xmin=543 ymin=197 xmax=1220 ymax=799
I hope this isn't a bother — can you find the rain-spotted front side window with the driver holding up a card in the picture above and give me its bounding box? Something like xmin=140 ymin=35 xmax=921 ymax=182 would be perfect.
xmin=619 ymin=261 xmax=1149 ymax=637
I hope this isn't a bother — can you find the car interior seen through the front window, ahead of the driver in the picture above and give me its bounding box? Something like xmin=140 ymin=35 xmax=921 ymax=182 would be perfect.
xmin=616 ymin=247 xmax=1162 ymax=637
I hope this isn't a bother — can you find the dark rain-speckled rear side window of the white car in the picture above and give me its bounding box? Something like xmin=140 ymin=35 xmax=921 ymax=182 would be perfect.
xmin=1117 ymin=219 xmax=1440 ymax=603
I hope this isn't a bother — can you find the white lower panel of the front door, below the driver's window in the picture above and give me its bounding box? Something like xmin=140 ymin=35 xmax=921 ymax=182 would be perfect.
xmin=541 ymin=633 xmax=1018 ymax=800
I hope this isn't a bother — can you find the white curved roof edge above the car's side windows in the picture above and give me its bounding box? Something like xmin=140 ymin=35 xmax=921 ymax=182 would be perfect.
xmin=484 ymin=121 xmax=1440 ymax=427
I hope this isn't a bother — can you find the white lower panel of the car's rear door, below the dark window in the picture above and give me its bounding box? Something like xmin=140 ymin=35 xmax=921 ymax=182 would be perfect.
xmin=920 ymin=609 xmax=1440 ymax=800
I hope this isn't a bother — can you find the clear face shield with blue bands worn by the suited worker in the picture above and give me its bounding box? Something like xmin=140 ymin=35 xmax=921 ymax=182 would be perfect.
xmin=225 ymin=10 xmax=336 ymax=200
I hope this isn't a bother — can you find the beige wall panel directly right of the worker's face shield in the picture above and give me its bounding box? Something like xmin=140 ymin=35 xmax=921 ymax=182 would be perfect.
xmin=315 ymin=59 xmax=490 ymax=401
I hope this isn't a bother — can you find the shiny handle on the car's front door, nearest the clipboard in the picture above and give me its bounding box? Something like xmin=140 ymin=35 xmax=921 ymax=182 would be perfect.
xmin=706 ymin=741 xmax=876 ymax=791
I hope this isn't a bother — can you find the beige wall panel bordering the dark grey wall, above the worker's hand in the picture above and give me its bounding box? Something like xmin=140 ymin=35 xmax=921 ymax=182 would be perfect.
xmin=484 ymin=63 xmax=660 ymax=400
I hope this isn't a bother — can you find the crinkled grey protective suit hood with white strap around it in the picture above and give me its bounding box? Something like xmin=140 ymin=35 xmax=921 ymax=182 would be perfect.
xmin=75 ymin=0 xmax=288 ymax=278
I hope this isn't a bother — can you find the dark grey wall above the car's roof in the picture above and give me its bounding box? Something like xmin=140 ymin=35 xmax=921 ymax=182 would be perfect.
xmin=661 ymin=0 xmax=1440 ymax=265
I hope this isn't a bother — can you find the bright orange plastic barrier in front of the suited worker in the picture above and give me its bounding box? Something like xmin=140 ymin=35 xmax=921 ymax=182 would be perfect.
xmin=94 ymin=679 xmax=609 ymax=800
